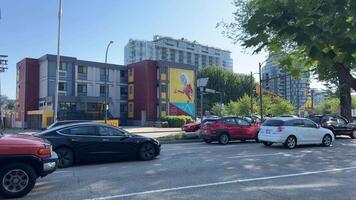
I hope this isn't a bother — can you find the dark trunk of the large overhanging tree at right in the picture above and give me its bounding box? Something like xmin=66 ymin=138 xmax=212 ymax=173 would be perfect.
xmin=336 ymin=65 xmax=355 ymax=121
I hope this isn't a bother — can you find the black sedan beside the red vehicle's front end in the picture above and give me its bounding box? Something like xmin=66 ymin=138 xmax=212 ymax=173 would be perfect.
xmin=35 ymin=122 xmax=161 ymax=168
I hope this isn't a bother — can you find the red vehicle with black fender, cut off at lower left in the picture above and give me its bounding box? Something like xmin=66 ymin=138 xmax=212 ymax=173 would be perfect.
xmin=0 ymin=133 xmax=58 ymax=198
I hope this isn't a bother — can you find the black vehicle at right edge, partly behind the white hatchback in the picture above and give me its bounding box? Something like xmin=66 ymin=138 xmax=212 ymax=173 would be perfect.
xmin=308 ymin=114 xmax=356 ymax=139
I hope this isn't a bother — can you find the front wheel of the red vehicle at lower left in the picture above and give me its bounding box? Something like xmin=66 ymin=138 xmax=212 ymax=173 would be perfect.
xmin=0 ymin=163 xmax=37 ymax=198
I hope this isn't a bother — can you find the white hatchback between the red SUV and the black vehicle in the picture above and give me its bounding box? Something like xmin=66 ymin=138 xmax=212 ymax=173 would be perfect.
xmin=258 ymin=117 xmax=334 ymax=149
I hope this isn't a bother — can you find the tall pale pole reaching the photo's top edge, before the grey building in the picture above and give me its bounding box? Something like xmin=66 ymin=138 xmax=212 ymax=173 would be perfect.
xmin=53 ymin=0 xmax=62 ymax=122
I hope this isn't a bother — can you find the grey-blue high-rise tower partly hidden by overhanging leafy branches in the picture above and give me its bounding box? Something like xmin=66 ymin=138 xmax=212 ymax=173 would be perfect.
xmin=262 ymin=56 xmax=310 ymax=109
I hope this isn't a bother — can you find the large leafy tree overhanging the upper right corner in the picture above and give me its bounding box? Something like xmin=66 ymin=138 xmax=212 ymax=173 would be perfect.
xmin=222 ymin=0 xmax=356 ymax=119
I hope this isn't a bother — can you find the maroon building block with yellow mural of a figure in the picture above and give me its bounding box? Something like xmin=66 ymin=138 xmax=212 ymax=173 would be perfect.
xmin=128 ymin=60 xmax=196 ymax=125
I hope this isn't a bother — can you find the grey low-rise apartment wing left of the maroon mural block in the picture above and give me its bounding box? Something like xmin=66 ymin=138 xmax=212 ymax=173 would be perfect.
xmin=17 ymin=54 xmax=128 ymax=126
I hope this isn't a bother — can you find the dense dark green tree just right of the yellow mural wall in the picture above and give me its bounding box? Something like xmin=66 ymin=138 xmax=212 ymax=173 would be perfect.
xmin=198 ymin=66 xmax=256 ymax=110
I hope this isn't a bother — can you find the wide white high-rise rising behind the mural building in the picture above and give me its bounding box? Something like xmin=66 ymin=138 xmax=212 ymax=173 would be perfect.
xmin=125 ymin=35 xmax=233 ymax=71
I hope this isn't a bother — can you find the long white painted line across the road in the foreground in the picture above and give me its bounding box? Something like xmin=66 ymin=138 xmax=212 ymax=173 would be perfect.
xmin=85 ymin=167 xmax=356 ymax=200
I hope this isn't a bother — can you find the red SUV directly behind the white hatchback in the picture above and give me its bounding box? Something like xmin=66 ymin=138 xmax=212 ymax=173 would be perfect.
xmin=201 ymin=117 xmax=260 ymax=144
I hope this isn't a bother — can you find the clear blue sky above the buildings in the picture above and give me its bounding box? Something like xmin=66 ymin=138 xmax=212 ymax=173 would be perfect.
xmin=0 ymin=0 xmax=266 ymax=98
